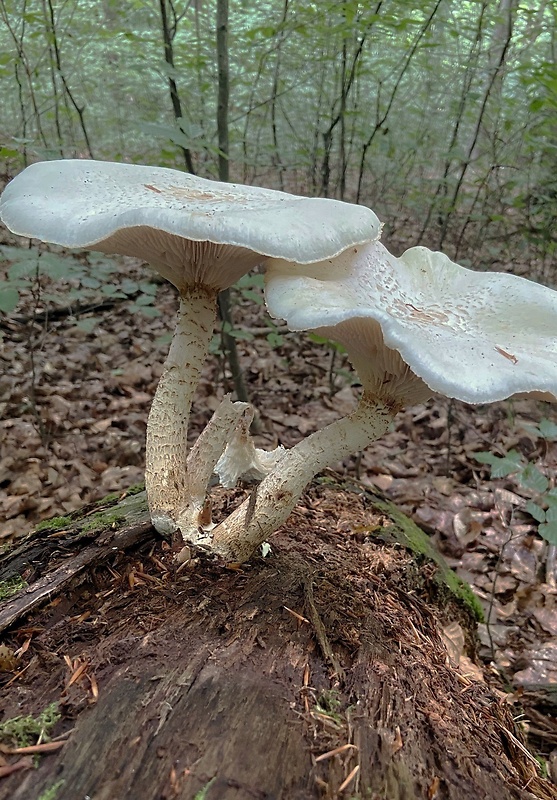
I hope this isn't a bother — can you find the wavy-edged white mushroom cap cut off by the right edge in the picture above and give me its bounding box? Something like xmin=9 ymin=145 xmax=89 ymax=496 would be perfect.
xmin=265 ymin=242 xmax=557 ymax=403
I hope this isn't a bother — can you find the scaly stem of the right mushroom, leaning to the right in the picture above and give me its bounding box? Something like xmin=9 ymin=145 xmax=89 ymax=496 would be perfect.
xmin=211 ymin=392 xmax=401 ymax=563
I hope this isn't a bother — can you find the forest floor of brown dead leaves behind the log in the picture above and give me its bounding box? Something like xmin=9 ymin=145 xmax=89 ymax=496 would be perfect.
xmin=0 ymin=240 xmax=557 ymax=766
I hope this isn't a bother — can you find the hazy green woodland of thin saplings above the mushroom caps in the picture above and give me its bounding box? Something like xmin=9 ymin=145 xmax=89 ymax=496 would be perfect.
xmin=0 ymin=0 xmax=557 ymax=274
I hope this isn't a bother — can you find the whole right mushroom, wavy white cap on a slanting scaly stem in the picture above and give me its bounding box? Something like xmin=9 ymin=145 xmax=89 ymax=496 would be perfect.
xmin=212 ymin=242 xmax=557 ymax=562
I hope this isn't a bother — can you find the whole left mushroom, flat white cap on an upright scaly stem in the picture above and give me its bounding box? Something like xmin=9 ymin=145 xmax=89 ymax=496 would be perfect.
xmin=0 ymin=160 xmax=379 ymax=533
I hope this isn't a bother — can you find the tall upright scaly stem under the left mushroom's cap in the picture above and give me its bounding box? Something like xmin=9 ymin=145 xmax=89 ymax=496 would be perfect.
xmin=145 ymin=288 xmax=217 ymax=534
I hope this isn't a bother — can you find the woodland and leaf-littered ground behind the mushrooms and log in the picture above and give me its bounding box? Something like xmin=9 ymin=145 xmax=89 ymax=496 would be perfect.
xmin=0 ymin=0 xmax=557 ymax=774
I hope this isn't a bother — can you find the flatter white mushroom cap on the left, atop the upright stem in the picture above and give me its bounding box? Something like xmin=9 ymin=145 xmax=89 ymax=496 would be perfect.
xmin=0 ymin=160 xmax=380 ymax=290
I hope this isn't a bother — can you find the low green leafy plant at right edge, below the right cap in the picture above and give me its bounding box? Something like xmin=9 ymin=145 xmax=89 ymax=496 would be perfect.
xmin=474 ymin=419 xmax=557 ymax=545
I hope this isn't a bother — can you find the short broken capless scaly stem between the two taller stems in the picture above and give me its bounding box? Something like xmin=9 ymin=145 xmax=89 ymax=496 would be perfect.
xmin=176 ymin=395 xmax=253 ymax=545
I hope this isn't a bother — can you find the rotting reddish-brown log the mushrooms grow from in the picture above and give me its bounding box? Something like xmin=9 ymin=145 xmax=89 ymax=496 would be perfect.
xmin=0 ymin=484 xmax=557 ymax=800
